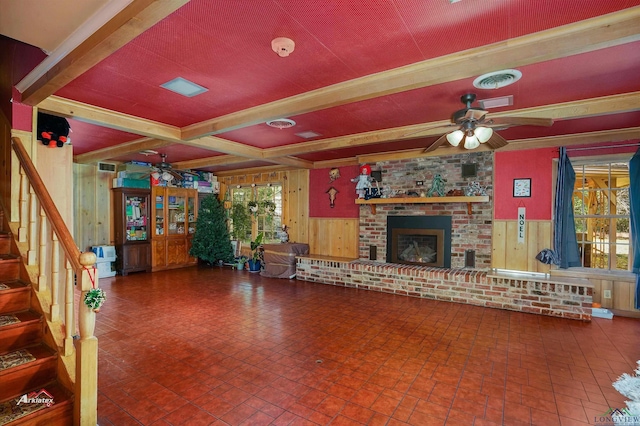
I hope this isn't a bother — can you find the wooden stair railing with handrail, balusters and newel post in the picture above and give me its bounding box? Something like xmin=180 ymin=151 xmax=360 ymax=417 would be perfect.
xmin=11 ymin=137 xmax=98 ymax=425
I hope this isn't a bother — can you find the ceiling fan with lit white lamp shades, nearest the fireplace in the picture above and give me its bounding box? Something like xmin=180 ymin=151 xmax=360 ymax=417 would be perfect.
xmin=424 ymin=93 xmax=553 ymax=152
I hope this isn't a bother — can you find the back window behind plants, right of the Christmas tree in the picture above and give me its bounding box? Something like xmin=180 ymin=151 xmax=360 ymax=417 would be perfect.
xmin=230 ymin=184 xmax=282 ymax=243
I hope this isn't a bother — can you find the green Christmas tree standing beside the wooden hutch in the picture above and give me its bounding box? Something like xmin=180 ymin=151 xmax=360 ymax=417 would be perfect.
xmin=189 ymin=194 xmax=233 ymax=264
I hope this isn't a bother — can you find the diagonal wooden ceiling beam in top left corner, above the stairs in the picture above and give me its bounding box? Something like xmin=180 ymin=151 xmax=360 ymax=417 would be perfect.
xmin=21 ymin=0 xmax=189 ymax=105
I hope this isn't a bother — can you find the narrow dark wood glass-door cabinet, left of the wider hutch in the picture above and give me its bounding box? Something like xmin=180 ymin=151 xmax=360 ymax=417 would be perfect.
xmin=113 ymin=188 xmax=151 ymax=275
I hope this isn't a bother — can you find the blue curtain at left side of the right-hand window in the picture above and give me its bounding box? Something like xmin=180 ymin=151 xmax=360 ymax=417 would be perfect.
xmin=553 ymin=147 xmax=582 ymax=269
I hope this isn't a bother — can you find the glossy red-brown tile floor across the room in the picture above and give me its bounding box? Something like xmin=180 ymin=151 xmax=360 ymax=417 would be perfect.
xmin=96 ymin=267 xmax=640 ymax=426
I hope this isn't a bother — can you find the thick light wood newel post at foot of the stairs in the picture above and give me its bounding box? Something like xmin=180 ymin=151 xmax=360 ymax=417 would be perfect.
xmin=74 ymin=252 xmax=98 ymax=426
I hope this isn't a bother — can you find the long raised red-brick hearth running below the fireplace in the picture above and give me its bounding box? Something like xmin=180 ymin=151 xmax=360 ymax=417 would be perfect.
xmin=296 ymin=257 xmax=593 ymax=321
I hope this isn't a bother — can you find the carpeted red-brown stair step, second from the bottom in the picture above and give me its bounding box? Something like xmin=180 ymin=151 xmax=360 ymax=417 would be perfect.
xmin=0 ymin=344 xmax=58 ymax=401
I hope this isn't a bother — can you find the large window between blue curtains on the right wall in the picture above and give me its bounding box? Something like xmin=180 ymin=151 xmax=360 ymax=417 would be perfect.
xmin=572 ymin=158 xmax=630 ymax=271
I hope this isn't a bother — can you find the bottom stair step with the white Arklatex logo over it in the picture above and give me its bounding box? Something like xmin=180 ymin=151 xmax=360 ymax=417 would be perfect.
xmin=0 ymin=382 xmax=73 ymax=426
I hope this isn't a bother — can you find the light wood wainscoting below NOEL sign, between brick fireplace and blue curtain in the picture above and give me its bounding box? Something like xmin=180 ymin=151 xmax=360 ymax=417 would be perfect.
xmin=491 ymin=220 xmax=553 ymax=273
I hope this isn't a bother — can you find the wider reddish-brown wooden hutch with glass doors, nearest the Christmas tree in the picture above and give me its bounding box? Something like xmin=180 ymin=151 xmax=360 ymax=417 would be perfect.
xmin=151 ymin=186 xmax=198 ymax=271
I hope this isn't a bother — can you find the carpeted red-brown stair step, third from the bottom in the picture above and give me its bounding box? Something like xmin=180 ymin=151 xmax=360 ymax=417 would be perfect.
xmin=0 ymin=310 xmax=44 ymax=354
